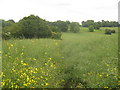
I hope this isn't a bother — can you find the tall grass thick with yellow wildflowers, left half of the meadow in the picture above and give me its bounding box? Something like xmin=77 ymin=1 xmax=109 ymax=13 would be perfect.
xmin=1 ymin=39 xmax=63 ymax=88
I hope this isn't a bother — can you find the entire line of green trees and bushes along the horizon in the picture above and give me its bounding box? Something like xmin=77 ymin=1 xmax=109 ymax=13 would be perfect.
xmin=2 ymin=15 xmax=119 ymax=39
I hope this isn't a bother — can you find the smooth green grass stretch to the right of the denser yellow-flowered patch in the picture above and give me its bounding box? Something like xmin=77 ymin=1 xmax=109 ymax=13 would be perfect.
xmin=62 ymin=32 xmax=118 ymax=88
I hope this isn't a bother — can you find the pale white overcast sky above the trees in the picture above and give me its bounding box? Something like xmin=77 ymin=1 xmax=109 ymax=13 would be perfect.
xmin=0 ymin=0 xmax=119 ymax=22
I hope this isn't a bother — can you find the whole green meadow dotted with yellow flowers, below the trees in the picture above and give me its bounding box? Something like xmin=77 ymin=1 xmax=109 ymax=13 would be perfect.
xmin=2 ymin=28 xmax=118 ymax=88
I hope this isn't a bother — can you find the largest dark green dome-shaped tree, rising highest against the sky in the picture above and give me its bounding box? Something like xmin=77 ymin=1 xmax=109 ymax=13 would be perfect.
xmin=19 ymin=15 xmax=52 ymax=38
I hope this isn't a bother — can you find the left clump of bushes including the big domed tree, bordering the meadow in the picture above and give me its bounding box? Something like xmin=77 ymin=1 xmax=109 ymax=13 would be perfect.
xmin=2 ymin=15 xmax=62 ymax=39
